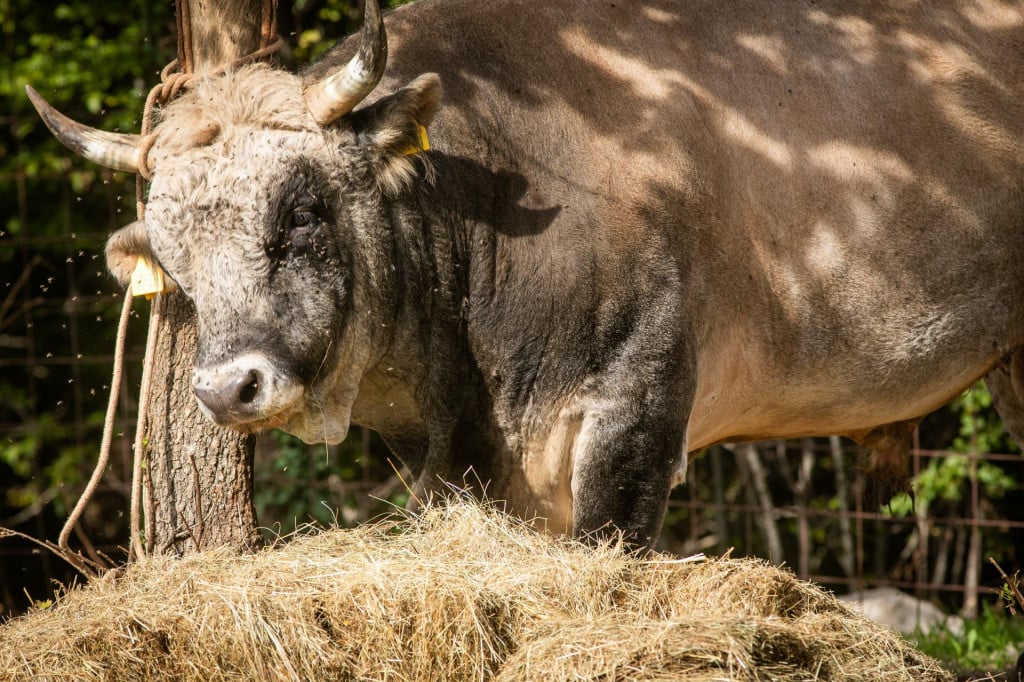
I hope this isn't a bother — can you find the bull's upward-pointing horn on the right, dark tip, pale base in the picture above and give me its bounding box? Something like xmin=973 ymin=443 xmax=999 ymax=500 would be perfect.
xmin=302 ymin=0 xmax=387 ymax=126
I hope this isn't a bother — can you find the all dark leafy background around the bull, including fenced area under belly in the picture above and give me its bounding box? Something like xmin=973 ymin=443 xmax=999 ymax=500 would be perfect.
xmin=0 ymin=0 xmax=1024 ymax=659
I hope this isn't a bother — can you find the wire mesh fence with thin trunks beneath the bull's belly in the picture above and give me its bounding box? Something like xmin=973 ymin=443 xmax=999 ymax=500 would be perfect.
xmin=666 ymin=438 xmax=1024 ymax=615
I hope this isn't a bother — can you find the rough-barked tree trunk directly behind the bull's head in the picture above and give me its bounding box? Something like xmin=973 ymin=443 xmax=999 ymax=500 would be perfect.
xmin=144 ymin=0 xmax=276 ymax=555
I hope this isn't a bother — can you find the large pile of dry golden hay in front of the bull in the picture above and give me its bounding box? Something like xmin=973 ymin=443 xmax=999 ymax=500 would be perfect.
xmin=0 ymin=504 xmax=951 ymax=682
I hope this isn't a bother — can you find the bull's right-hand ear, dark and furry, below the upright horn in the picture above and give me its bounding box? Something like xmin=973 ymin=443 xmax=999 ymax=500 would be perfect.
xmin=350 ymin=74 xmax=441 ymax=196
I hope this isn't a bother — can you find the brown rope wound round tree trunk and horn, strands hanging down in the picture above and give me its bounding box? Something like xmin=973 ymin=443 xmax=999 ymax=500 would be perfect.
xmin=57 ymin=0 xmax=285 ymax=561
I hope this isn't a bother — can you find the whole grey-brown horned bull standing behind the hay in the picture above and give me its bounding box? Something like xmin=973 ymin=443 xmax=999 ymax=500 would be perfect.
xmin=30 ymin=0 xmax=1024 ymax=545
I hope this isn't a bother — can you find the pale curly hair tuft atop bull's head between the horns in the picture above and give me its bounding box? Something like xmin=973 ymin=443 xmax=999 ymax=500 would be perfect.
xmin=153 ymin=63 xmax=318 ymax=168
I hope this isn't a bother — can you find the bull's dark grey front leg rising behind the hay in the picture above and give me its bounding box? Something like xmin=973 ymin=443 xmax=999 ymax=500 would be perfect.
xmin=571 ymin=360 xmax=693 ymax=549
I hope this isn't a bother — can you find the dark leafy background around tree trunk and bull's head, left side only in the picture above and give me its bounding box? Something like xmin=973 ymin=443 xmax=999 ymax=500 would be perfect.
xmin=0 ymin=0 xmax=413 ymax=617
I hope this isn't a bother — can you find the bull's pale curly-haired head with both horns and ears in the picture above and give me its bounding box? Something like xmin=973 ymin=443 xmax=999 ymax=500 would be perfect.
xmin=29 ymin=0 xmax=440 ymax=441
